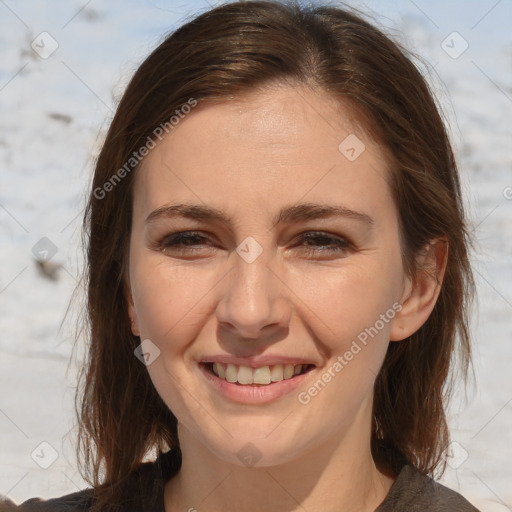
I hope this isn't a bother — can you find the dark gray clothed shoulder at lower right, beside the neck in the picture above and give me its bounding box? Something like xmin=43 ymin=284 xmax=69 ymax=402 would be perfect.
xmin=376 ymin=466 xmax=479 ymax=512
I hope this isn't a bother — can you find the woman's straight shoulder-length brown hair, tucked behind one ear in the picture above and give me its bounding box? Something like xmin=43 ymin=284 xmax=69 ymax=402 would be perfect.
xmin=77 ymin=1 xmax=473 ymax=510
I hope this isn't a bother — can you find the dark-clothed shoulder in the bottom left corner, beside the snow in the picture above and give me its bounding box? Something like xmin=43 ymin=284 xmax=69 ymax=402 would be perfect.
xmin=0 ymin=489 xmax=94 ymax=512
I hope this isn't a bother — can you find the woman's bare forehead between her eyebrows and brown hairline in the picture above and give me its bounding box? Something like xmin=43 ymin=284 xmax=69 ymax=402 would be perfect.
xmin=135 ymin=87 xmax=389 ymax=220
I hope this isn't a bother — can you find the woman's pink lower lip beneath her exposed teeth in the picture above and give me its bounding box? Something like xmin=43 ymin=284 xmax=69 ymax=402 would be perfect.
xmin=199 ymin=364 xmax=313 ymax=404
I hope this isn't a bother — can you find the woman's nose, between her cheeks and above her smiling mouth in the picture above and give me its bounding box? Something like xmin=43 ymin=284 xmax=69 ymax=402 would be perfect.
xmin=216 ymin=247 xmax=291 ymax=345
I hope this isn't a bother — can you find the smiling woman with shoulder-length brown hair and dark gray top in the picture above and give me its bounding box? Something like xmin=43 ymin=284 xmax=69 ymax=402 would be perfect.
xmin=3 ymin=2 xmax=476 ymax=512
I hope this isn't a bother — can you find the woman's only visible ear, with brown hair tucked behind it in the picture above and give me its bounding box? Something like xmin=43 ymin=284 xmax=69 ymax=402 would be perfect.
xmin=390 ymin=238 xmax=448 ymax=341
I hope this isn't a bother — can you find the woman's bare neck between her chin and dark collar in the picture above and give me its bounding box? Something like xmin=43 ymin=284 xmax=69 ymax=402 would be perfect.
xmin=164 ymin=412 xmax=394 ymax=512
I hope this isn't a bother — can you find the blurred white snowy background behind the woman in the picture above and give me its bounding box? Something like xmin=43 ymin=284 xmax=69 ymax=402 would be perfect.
xmin=0 ymin=0 xmax=512 ymax=512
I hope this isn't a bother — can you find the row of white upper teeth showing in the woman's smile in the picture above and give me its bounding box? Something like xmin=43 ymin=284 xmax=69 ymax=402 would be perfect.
xmin=202 ymin=363 xmax=315 ymax=386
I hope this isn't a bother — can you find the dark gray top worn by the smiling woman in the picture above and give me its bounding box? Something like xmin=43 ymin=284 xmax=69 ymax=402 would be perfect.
xmin=0 ymin=452 xmax=479 ymax=512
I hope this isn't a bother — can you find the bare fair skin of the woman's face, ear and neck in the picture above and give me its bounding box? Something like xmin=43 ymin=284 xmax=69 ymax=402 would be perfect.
xmin=127 ymin=85 xmax=445 ymax=512
